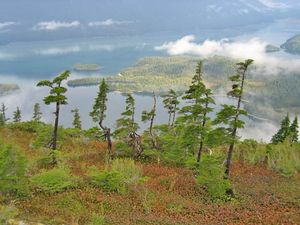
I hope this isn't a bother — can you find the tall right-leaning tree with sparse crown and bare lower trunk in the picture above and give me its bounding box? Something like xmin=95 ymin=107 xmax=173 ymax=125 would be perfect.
xmin=215 ymin=59 xmax=253 ymax=177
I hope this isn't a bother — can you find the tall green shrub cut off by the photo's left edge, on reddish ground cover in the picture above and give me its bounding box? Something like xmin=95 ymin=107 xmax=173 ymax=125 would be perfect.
xmin=0 ymin=145 xmax=27 ymax=196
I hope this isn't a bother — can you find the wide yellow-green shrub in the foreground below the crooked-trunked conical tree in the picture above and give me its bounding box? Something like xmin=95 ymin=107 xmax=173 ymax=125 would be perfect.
xmin=89 ymin=159 xmax=145 ymax=193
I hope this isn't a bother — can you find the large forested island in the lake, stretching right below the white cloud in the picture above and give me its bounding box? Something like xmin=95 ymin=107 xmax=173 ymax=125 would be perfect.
xmin=68 ymin=56 xmax=300 ymax=120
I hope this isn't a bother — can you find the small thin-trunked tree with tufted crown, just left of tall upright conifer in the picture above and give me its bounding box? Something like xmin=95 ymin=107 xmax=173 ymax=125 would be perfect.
xmin=162 ymin=89 xmax=179 ymax=126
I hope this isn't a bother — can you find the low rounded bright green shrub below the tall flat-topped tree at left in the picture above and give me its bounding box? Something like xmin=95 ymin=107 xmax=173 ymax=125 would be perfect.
xmin=31 ymin=168 xmax=80 ymax=193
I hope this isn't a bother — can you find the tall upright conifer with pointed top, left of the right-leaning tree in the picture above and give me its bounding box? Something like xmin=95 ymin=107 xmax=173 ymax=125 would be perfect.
xmin=180 ymin=61 xmax=215 ymax=163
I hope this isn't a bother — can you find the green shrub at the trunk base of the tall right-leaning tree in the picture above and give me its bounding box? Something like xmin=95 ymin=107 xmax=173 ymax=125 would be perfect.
xmin=197 ymin=155 xmax=232 ymax=201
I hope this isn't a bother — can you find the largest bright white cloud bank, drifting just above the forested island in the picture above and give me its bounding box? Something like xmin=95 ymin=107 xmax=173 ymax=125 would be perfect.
xmin=155 ymin=35 xmax=300 ymax=74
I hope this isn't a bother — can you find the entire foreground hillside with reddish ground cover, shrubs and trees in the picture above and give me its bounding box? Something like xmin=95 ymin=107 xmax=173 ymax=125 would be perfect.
xmin=0 ymin=59 xmax=300 ymax=225
